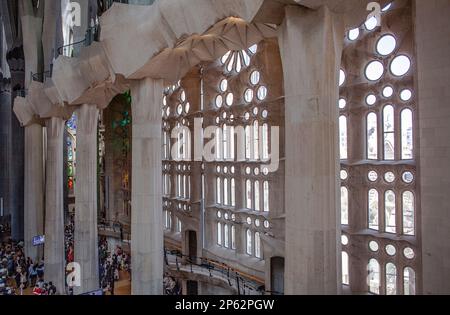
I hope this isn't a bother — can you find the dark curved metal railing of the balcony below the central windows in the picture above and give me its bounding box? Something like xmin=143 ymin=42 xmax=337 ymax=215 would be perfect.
xmin=164 ymin=249 xmax=282 ymax=295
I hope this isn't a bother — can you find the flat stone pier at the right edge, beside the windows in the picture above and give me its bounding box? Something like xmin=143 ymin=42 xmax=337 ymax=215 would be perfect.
xmin=413 ymin=0 xmax=450 ymax=294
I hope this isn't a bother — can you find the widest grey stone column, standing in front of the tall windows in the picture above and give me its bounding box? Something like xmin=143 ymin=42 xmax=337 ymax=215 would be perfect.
xmin=279 ymin=6 xmax=344 ymax=294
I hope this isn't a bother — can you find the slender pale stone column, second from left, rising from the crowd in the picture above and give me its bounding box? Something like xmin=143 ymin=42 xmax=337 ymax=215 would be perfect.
xmin=44 ymin=118 xmax=65 ymax=294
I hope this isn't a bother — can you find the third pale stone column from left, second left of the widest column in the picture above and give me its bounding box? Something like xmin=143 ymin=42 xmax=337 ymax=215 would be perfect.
xmin=74 ymin=104 xmax=99 ymax=294
